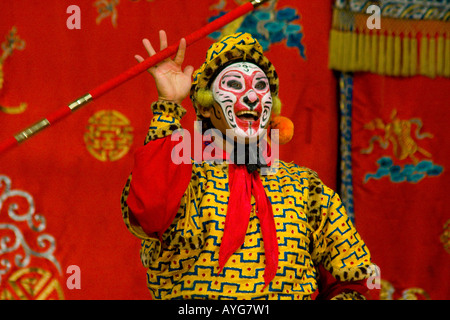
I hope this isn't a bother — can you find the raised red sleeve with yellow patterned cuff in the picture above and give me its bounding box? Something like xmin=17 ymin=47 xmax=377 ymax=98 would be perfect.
xmin=121 ymin=102 xmax=192 ymax=240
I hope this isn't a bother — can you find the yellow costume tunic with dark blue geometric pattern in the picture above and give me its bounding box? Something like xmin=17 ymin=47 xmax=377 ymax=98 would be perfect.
xmin=122 ymin=100 xmax=370 ymax=299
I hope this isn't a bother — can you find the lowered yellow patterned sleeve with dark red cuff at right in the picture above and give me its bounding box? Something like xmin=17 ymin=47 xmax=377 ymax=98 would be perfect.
xmin=308 ymin=170 xmax=371 ymax=300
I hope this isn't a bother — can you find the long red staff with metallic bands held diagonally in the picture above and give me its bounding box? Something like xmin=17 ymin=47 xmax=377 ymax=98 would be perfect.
xmin=0 ymin=0 xmax=268 ymax=155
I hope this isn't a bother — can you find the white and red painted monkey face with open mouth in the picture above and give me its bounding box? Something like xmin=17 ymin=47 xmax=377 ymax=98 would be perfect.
xmin=212 ymin=62 xmax=272 ymax=137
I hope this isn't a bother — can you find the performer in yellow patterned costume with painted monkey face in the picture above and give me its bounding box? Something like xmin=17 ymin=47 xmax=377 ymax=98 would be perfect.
xmin=121 ymin=31 xmax=371 ymax=299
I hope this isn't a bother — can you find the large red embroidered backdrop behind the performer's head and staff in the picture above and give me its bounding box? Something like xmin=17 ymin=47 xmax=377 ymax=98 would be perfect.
xmin=0 ymin=0 xmax=338 ymax=299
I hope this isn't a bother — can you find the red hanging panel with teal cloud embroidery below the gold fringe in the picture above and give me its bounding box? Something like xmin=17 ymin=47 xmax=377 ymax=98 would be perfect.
xmin=352 ymin=74 xmax=450 ymax=299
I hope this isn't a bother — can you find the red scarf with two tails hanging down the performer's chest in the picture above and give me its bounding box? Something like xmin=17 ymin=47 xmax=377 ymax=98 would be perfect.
xmin=204 ymin=139 xmax=278 ymax=286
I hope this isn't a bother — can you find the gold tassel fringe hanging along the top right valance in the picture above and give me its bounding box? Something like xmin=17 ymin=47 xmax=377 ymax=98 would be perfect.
xmin=329 ymin=9 xmax=450 ymax=78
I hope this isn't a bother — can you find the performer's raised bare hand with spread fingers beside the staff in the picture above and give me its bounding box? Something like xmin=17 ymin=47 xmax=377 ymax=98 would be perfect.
xmin=134 ymin=30 xmax=194 ymax=104
